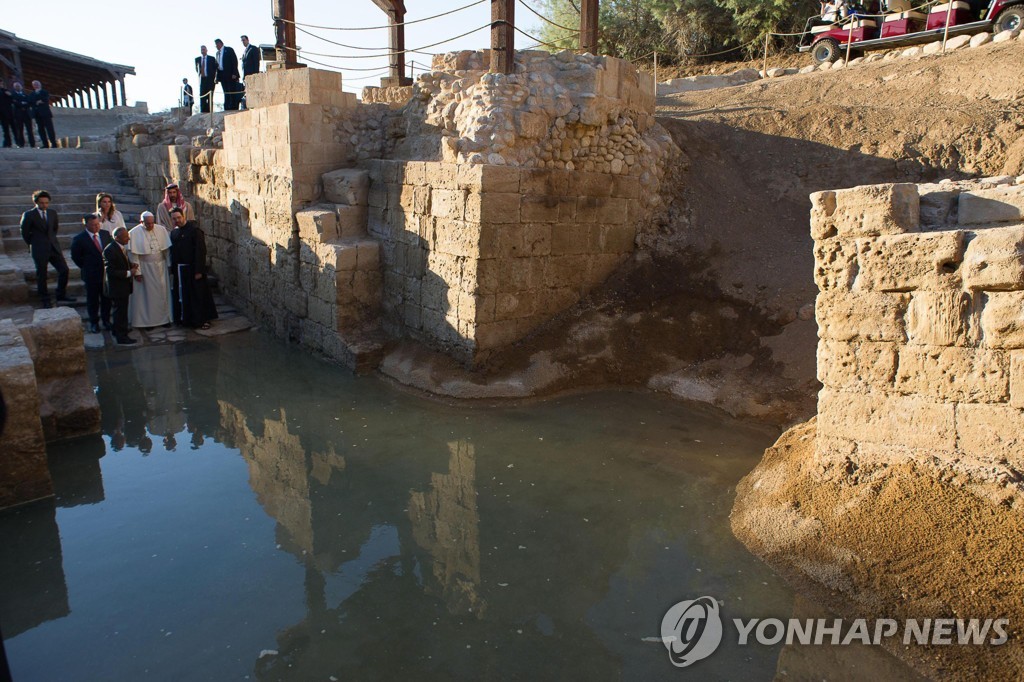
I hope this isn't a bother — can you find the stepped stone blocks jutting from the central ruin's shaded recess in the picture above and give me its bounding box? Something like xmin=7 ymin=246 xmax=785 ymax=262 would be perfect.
xmin=295 ymin=169 xmax=385 ymax=372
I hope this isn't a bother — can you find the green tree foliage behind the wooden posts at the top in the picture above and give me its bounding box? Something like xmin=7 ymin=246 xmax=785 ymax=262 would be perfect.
xmin=517 ymin=0 xmax=818 ymax=62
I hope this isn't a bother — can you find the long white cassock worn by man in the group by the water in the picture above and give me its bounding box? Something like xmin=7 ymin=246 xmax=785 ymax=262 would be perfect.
xmin=128 ymin=223 xmax=171 ymax=328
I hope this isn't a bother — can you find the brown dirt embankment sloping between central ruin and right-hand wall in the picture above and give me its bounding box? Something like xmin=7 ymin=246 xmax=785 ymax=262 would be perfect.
xmin=395 ymin=40 xmax=1024 ymax=424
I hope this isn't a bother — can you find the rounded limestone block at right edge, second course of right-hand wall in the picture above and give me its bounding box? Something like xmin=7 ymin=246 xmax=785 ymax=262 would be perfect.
xmin=964 ymin=225 xmax=1024 ymax=291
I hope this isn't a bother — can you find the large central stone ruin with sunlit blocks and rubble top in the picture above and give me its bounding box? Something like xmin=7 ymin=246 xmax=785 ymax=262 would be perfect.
xmin=119 ymin=52 xmax=678 ymax=369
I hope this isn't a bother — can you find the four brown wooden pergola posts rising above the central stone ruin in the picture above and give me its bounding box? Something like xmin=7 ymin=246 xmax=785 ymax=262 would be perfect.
xmin=273 ymin=0 xmax=600 ymax=80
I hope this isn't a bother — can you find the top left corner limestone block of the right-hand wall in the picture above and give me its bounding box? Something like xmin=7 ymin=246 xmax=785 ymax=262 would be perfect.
xmin=811 ymin=183 xmax=921 ymax=240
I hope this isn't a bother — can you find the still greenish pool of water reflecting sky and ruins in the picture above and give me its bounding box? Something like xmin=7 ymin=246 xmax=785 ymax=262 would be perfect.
xmin=0 ymin=333 xmax=823 ymax=680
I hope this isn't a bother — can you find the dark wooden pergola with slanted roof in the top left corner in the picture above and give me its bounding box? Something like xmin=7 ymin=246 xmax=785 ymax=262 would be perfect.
xmin=0 ymin=31 xmax=135 ymax=109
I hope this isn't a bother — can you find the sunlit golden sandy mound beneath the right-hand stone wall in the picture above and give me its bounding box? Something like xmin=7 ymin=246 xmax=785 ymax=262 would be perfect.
xmin=731 ymin=421 xmax=1024 ymax=680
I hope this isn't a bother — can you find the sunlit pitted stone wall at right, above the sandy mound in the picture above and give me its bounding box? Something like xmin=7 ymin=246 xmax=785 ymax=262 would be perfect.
xmin=811 ymin=178 xmax=1024 ymax=473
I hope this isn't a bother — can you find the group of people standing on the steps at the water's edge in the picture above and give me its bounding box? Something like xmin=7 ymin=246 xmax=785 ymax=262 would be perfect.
xmin=22 ymin=183 xmax=217 ymax=345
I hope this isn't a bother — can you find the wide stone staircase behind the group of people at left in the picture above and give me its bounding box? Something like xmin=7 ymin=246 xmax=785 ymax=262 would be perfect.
xmin=0 ymin=148 xmax=147 ymax=306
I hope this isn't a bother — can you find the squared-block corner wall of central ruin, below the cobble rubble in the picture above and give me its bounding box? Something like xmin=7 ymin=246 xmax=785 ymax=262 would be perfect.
xmin=368 ymin=161 xmax=641 ymax=363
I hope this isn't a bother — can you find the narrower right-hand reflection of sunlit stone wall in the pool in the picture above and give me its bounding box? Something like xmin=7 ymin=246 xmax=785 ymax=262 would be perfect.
xmin=409 ymin=441 xmax=483 ymax=615
